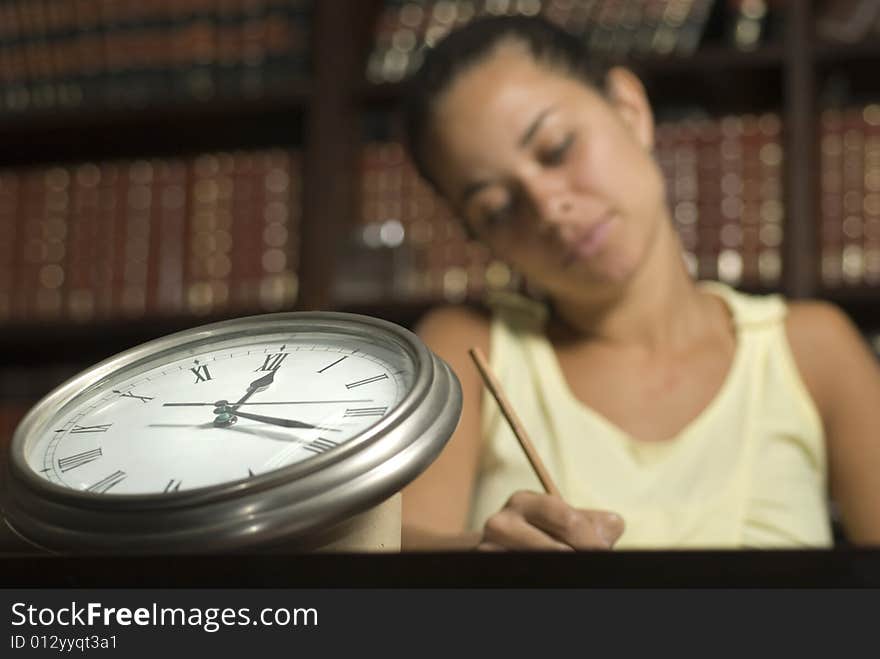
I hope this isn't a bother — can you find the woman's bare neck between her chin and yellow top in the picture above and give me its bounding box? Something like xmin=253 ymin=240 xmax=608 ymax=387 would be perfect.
xmin=553 ymin=222 xmax=717 ymax=352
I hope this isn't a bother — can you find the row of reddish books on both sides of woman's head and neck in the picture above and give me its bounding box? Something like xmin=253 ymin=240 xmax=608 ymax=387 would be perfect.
xmin=336 ymin=113 xmax=785 ymax=301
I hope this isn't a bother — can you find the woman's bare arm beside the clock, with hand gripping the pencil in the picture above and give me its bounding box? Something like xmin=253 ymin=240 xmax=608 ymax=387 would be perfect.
xmin=403 ymin=307 xmax=623 ymax=551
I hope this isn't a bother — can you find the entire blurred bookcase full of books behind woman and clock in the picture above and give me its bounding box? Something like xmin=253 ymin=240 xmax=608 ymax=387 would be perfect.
xmin=0 ymin=0 xmax=880 ymax=443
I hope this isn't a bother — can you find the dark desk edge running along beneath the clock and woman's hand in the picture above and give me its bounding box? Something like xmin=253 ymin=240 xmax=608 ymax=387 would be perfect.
xmin=0 ymin=549 xmax=880 ymax=588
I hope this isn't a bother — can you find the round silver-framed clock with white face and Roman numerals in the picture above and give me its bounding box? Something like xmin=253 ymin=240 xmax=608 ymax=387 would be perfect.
xmin=3 ymin=312 xmax=461 ymax=553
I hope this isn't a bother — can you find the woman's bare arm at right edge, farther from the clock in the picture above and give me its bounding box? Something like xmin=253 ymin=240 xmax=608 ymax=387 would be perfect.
xmin=787 ymin=302 xmax=880 ymax=544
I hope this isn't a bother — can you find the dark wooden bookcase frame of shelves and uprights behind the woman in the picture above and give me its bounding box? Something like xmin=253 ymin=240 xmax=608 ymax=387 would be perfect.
xmin=0 ymin=0 xmax=880 ymax=444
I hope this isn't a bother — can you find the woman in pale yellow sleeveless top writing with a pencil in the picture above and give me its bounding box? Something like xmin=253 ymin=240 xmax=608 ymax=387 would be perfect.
xmin=404 ymin=17 xmax=880 ymax=550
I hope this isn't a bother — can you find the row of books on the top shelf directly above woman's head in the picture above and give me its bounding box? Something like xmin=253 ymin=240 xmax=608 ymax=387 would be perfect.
xmin=367 ymin=0 xmax=713 ymax=83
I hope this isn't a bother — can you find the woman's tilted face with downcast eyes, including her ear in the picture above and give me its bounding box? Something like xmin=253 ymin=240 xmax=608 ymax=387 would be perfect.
xmin=426 ymin=45 xmax=666 ymax=302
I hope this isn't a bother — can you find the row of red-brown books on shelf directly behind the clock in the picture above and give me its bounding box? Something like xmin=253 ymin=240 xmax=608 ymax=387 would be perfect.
xmin=0 ymin=150 xmax=301 ymax=322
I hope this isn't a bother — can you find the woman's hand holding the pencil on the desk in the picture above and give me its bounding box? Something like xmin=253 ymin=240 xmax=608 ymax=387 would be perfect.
xmin=477 ymin=490 xmax=624 ymax=551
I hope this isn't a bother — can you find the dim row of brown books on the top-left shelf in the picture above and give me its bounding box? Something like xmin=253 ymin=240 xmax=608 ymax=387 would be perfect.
xmin=0 ymin=0 xmax=312 ymax=115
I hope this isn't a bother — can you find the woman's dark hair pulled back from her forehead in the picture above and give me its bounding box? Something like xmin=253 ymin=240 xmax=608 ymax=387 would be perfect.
xmin=404 ymin=16 xmax=608 ymax=187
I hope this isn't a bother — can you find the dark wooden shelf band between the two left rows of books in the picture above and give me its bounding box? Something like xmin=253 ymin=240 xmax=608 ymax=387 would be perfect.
xmin=0 ymin=81 xmax=312 ymax=166
